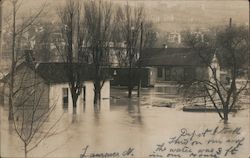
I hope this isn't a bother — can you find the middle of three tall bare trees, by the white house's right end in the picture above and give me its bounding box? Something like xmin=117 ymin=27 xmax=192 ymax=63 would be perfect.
xmin=84 ymin=0 xmax=112 ymax=105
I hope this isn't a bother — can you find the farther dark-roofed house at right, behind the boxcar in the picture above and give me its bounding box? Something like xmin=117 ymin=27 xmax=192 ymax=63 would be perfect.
xmin=141 ymin=48 xmax=220 ymax=82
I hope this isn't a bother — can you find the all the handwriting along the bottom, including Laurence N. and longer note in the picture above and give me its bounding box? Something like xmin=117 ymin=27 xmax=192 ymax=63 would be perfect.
xmin=80 ymin=127 xmax=246 ymax=158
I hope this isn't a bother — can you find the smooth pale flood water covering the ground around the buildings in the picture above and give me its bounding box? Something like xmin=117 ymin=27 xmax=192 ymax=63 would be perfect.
xmin=0 ymin=87 xmax=250 ymax=158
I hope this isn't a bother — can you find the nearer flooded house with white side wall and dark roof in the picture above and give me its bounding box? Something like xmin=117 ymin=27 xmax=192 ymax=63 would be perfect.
xmin=2 ymin=62 xmax=110 ymax=108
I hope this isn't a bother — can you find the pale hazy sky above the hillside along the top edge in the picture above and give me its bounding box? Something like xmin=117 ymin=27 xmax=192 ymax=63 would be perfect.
xmin=1 ymin=0 xmax=249 ymax=31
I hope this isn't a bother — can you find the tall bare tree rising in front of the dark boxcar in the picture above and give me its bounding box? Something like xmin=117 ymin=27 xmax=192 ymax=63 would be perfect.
xmin=113 ymin=5 xmax=157 ymax=98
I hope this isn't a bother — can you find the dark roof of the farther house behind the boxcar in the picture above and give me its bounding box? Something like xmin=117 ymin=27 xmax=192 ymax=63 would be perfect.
xmin=141 ymin=48 xmax=213 ymax=66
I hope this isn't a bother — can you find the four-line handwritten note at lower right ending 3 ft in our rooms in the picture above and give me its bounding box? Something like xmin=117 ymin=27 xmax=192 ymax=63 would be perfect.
xmin=149 ymin=127 xmax=245 ymax=158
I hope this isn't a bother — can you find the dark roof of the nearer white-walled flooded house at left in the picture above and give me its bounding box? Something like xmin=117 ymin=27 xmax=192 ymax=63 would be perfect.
xmin=3 ymin=62 xmax=109 ymax=84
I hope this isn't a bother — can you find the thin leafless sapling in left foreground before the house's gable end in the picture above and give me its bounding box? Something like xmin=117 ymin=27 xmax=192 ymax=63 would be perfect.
xmin=12 ymin=60 xmax=62 ymax=158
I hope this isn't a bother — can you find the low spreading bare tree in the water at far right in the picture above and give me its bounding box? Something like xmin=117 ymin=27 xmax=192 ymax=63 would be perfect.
xmin=181 ymin=25 xmax=248 ymax=122
